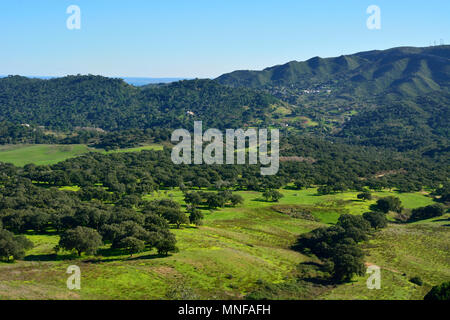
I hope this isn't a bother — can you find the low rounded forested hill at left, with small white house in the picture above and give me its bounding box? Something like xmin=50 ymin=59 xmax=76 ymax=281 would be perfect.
xmin=0 ymin=75 xmax=280 ymax=131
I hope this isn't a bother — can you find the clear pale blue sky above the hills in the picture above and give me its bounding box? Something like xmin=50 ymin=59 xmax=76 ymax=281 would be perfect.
xmin=0 ymin=0 xmax=450 ymax=78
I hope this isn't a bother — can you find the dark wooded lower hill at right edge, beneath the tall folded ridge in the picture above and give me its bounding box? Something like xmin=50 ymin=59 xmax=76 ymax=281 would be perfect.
xmin=337 ymin=92 xmax=450 ymax=151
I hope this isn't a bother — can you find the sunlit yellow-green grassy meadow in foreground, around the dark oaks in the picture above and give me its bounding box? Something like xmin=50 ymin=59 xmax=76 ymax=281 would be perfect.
xmin=0 ymin=189 xmax=450 ymax=299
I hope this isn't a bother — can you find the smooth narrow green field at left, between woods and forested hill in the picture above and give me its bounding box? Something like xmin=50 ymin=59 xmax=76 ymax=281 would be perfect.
xmin=0 ymin=144 xmax=163 ymax=167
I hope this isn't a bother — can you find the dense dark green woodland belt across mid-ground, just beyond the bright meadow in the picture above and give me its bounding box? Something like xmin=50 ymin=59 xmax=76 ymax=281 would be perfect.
xmin=0 ymin=136 xmax=450 ymax=199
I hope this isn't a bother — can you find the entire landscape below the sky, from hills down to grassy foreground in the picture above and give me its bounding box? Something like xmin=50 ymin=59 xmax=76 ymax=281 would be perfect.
xmin=0 ymin=46 xmax=450 ymax=300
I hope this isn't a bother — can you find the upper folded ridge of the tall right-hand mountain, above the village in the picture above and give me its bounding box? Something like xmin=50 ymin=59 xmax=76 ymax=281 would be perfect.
xmin=216 ymin=46 xmax=450 ymax=96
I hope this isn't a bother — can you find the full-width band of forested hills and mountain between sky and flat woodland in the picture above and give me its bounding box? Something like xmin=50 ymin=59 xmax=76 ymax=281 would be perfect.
xmin=0 ymin=46 xmax=450 ymax=156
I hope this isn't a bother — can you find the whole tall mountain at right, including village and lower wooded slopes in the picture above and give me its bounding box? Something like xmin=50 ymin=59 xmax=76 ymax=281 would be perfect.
xmin=216 ymin=46 xmax=450 ymax=153
